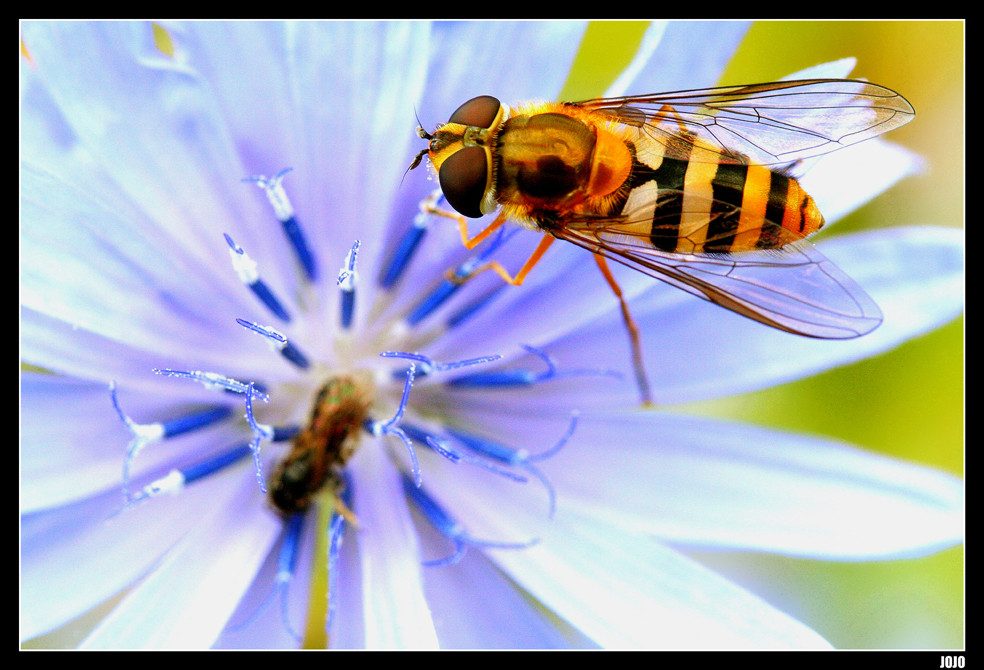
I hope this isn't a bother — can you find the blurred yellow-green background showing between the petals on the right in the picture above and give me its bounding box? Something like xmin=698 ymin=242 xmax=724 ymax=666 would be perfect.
xmin=565 ymin=21 xmax=965 ymax=649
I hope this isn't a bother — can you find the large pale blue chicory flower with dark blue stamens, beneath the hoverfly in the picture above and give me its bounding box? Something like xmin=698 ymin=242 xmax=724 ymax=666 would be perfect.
xmin=20 ymin=21 xmax=963 ymax=648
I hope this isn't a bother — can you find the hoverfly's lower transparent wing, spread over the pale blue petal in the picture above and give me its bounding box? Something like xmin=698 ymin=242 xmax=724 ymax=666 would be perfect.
xmin=551 ymin=200 xmax=882 ymax=339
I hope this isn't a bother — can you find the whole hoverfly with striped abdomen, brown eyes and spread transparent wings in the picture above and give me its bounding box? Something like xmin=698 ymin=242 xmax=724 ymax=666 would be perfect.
xmin=410 ymin=79 xmax=914 ymax=399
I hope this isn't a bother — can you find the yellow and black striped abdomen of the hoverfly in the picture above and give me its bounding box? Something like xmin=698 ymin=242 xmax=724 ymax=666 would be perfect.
xmin=622 ymin=152 xmax=823 ymax=253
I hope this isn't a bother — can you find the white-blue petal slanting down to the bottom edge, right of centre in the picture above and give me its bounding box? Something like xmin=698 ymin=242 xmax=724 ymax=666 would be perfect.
xmin=412 ymin=469 xmax=829 ymax=649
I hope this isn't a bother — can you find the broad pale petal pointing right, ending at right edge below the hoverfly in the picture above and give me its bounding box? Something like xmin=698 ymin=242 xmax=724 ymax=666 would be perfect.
xmin=436 ymin=410 xmax=964 ymax=560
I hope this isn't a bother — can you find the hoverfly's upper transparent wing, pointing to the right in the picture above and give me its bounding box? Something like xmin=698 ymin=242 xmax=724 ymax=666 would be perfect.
xmin=566 ymin=79 xmax=915 ymax=165
